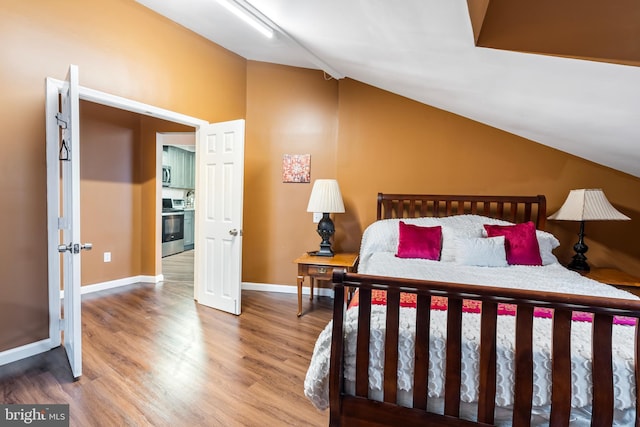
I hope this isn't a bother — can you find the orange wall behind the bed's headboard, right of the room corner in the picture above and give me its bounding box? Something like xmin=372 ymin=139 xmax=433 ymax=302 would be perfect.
xmin=336 ymin=79 xmax=640 ymax=276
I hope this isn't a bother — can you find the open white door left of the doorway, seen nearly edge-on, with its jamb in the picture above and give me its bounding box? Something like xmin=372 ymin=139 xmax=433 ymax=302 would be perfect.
xmin=47 ymin=65 xmax=86 ymax=378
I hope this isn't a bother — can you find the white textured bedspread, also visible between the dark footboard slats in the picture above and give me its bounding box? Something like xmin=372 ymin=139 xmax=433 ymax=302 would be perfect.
xmin=304 ymin=252 xmax=638 ymax=410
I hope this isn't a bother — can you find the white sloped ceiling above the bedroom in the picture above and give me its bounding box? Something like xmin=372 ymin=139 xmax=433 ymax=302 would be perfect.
xmin=136 ymin=0 xmax=640 ymax=177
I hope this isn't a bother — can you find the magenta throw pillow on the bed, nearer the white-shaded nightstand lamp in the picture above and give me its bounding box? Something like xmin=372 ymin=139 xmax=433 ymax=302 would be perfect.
xmin=396 ymin=221 xmax=442 ymax=261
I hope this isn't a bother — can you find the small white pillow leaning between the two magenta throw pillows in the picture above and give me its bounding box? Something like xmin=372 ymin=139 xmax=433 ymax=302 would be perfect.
xmin=455 ymin=236 xmax=509 ymax=267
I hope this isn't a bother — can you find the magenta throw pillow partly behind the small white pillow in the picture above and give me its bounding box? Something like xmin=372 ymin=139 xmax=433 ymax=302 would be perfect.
xmin=484 ymin=221 xmax=542 ymax=265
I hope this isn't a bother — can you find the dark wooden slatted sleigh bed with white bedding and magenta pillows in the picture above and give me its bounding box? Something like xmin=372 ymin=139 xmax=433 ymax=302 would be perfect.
xmin=305 ymin=194 xmax=640 ymax=426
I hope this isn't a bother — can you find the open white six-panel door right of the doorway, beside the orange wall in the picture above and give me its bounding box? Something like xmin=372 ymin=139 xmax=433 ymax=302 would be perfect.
xmin=194 ymin=120 xmax=244 ymax=314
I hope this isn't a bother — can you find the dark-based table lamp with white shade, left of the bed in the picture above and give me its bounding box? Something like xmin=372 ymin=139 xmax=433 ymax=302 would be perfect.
xmin=307 ymin=179 xmax=344 ymax=257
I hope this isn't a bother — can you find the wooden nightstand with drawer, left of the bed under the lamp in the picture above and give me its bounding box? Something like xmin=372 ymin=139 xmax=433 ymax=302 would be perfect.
xmin=293 ymin=253 xmax=358 ymax=317
